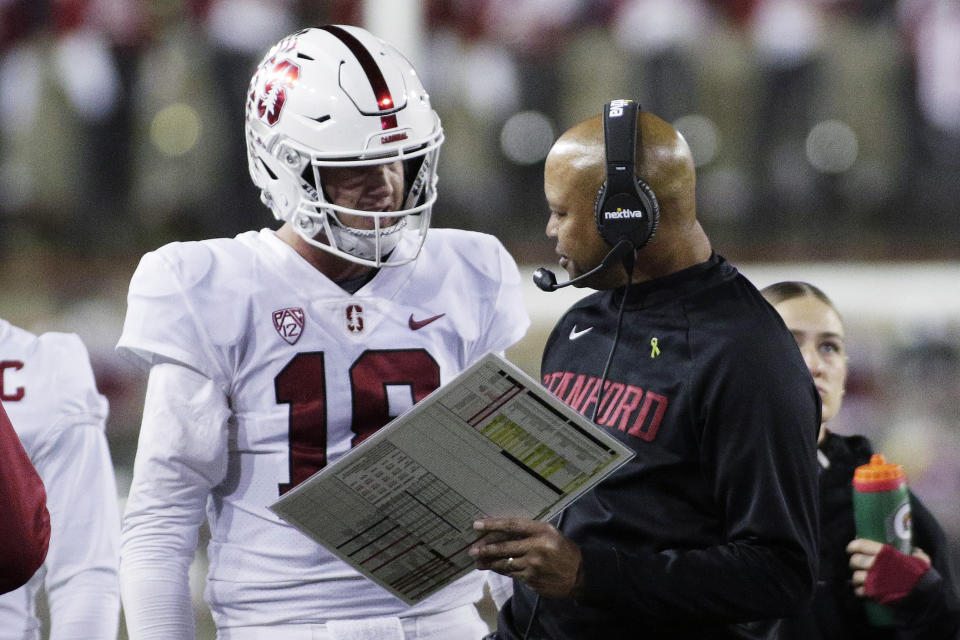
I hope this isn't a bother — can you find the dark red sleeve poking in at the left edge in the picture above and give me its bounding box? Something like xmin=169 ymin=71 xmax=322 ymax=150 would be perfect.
xmin=0 ymin=405 xmax=50 ymax=593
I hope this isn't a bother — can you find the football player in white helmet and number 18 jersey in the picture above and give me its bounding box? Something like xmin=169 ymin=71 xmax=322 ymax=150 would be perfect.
xmin=118 ymin=25 xmax=529 ymax=640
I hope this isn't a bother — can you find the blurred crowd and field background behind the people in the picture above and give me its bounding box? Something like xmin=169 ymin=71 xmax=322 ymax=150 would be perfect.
xmin=0 ymin=0 xmax=960 ymax=636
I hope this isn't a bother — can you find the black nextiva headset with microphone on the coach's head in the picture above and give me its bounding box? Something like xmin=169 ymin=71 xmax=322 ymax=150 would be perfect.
xmin=533 ymin=99 xmax=660 ymax=291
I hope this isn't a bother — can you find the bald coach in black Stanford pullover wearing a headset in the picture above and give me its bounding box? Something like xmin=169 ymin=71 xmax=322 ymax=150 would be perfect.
xmin=471 ymin=100 xmax=820 ymax=640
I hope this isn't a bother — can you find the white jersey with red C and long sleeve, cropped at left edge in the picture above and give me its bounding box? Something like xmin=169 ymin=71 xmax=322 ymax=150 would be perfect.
xmin=0 ymin=319 xmax=120 ymax=640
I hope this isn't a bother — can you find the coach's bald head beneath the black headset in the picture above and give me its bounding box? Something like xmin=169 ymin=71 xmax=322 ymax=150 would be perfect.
xmin=544 ymin=112 xmax=710 ymax=289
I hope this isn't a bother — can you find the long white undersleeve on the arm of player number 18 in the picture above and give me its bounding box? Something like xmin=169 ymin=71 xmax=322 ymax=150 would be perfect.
xmin=120 ymin=363 xmax=230 ymax=640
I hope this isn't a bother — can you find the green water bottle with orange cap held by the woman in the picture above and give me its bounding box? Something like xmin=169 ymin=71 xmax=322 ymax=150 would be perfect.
xmin=853 ymin=453 xmax=913 ymax=627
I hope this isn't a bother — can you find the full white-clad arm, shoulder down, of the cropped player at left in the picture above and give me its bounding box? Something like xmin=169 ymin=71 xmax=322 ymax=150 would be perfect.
xmin=24 ymin=332 xmax=120 ymax=640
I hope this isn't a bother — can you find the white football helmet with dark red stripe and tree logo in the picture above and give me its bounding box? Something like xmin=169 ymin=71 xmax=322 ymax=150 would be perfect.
xmin=245 ymin=25 xmax=443 ymax=267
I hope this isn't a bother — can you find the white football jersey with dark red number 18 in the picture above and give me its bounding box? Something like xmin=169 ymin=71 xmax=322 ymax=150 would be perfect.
xmin=118 ymin=229 xmax=529 ymax=627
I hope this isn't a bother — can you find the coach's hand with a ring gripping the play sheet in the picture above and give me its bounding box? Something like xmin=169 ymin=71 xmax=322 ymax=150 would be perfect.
xmin=470 ymin=518 xmax=583 ymax=598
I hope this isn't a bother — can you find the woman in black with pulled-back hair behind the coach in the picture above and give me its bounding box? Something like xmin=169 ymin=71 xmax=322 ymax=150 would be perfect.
xmin=761 ymin=282 xmax=960 ymax=640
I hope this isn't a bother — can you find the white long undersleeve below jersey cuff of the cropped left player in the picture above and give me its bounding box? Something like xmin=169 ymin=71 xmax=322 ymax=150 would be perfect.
xmin=38 ymin=424 xmax=120 ymax=640
